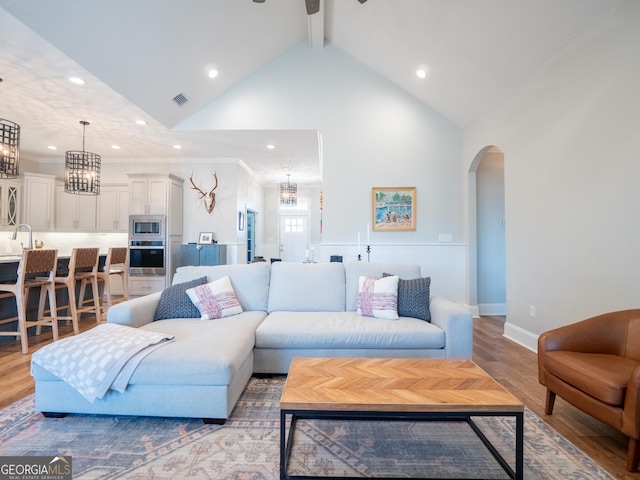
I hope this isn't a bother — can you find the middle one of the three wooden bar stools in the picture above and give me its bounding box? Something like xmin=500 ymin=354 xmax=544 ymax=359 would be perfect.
xmin=48 ymin=248 xmax=101 ymax=335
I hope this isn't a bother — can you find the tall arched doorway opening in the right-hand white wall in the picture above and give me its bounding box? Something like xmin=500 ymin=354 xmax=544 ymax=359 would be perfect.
xmin=469 ymin=146 xmax=506 ymax=315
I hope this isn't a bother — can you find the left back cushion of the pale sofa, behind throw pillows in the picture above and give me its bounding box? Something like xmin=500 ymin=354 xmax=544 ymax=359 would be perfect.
xmin=173 ymin=262 xmax=271 ymax=312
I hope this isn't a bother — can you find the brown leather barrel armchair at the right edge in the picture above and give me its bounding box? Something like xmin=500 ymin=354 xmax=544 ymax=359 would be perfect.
xmin=538 ymin=309 xmax=640 ymax=472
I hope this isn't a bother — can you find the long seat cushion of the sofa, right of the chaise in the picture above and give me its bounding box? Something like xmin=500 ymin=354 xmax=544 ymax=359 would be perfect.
xmin=256 ymin=312 xmax=445 ymax=349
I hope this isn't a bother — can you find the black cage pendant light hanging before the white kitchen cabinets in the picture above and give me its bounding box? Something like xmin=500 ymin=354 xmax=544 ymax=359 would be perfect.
xmin=64 ymin=120 xmax=100 ymax=195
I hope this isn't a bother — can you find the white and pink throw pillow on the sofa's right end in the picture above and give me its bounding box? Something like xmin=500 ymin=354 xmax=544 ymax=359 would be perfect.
xmin=357 ymin=275 xmax=399 ymax=320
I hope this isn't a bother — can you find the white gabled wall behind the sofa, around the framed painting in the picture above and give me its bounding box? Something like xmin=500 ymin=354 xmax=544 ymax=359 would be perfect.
xmin=178 ymin=43 xmax=465 ymax=301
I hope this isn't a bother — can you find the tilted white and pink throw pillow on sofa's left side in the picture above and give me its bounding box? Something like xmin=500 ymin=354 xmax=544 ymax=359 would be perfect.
xmin=187 ymin=277 xmax=242 ymax=320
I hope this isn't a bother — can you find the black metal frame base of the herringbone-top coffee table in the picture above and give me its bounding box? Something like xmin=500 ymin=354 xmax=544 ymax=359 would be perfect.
xmin=280 ymin=409 xmax=524 ymax=480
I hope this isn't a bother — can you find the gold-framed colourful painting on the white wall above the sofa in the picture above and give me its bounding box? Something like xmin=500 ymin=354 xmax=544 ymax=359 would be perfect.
xmin=371 ymin=187 xmax=417 ymax=232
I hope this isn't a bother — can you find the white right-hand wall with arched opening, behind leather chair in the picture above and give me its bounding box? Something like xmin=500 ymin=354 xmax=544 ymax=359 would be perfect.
xmin=464 ymin=0 xmax=640 ymax=348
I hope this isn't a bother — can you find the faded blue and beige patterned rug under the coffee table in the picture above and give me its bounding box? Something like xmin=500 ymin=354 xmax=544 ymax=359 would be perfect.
xmin=0 ymin=377 xmax=613 ymax=480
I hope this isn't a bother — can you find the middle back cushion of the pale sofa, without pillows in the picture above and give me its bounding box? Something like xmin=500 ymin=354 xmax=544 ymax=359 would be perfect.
xmin=268 ymin=262 xmax=345 ymax=313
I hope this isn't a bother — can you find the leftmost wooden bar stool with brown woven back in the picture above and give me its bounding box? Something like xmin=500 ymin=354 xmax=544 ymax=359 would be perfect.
xmin=0 ymin=250 xmax=58 ymax=354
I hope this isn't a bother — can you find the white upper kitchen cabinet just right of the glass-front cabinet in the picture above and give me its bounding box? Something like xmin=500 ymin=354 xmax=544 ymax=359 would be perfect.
xmin=21 ymin=173 xmax=56 ymax=232
